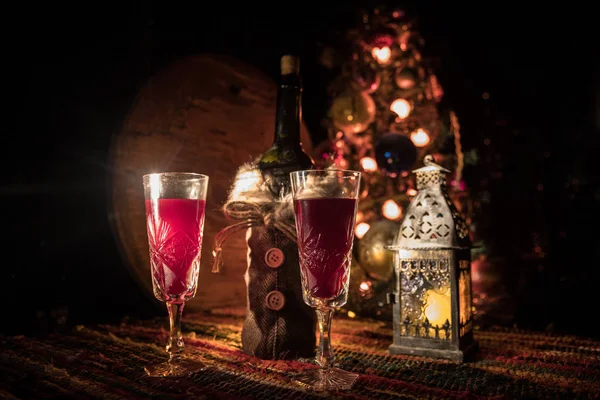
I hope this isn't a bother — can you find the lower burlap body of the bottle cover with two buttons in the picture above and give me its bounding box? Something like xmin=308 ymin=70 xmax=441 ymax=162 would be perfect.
xmin=242 ymin=226 xmax=315 ymax=359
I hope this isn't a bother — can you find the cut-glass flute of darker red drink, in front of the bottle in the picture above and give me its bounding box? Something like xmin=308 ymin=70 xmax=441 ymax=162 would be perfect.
xmin=290 ymin=170 xmax=361 ymax=391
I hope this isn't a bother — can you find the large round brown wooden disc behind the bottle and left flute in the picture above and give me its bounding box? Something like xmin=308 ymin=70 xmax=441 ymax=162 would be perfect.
xmin=110 ymin=55 xmax=312 ymax=311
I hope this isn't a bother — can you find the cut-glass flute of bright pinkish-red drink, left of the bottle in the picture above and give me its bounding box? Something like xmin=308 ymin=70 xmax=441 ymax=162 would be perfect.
xmin=143 ymin=172 xmax=208 ymax=376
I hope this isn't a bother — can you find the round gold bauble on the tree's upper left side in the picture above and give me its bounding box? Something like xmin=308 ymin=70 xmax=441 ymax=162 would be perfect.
xmin=331 ymin=89 xmax=375 ymax=136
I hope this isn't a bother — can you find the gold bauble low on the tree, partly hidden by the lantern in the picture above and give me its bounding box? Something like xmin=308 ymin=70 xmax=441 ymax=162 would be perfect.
xmin=358 ymin=220 xmax=400 ymax=280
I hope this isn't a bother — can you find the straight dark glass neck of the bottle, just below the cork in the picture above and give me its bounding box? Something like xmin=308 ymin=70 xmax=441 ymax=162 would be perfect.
xmin=274 ymin=74 xmax=302 ymax=147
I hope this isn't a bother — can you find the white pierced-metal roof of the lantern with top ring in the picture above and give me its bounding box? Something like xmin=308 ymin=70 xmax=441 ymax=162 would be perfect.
xmin=387 ymin=155 xmax=471 ymax=250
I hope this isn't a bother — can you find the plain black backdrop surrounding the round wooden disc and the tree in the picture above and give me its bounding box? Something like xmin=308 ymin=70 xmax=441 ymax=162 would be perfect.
xmin=0 ymin=1 xmax=600 ymax=336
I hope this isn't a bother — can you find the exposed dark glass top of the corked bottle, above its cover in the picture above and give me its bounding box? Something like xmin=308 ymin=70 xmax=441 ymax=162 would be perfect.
xmin=258 ymin=55 xmax=314 ymax=196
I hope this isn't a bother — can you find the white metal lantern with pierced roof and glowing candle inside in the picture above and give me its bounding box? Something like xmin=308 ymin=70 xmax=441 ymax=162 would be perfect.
xmin=388 ymin=155 xmax=477 ymax=362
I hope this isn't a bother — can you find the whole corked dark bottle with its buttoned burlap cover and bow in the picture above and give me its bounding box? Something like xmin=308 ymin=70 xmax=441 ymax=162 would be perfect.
xmin=215 ymin=55 xmax=316 ymax=360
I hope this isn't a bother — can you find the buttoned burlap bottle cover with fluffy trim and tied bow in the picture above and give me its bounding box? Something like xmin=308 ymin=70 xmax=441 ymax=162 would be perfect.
xmin=213 ymin=164 xmax=316 ymax=360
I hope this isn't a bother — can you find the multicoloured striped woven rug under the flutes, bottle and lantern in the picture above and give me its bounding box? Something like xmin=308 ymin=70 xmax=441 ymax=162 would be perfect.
xmin=0 ymin=313 xmax=600 ymax=400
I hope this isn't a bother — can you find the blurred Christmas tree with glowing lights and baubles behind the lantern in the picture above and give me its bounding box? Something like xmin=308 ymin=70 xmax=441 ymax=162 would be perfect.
xmin=315 ymin=9 xmax=486 ymax=320
